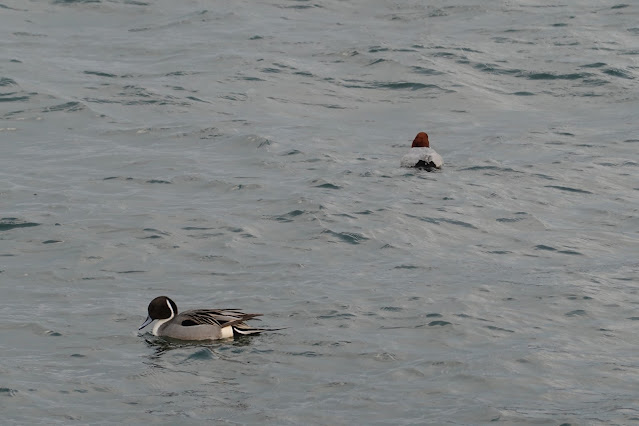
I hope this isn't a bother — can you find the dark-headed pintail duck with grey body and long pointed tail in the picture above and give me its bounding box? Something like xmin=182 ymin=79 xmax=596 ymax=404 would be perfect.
xmin=138 ymin=296 xmax=275 ymax=340
